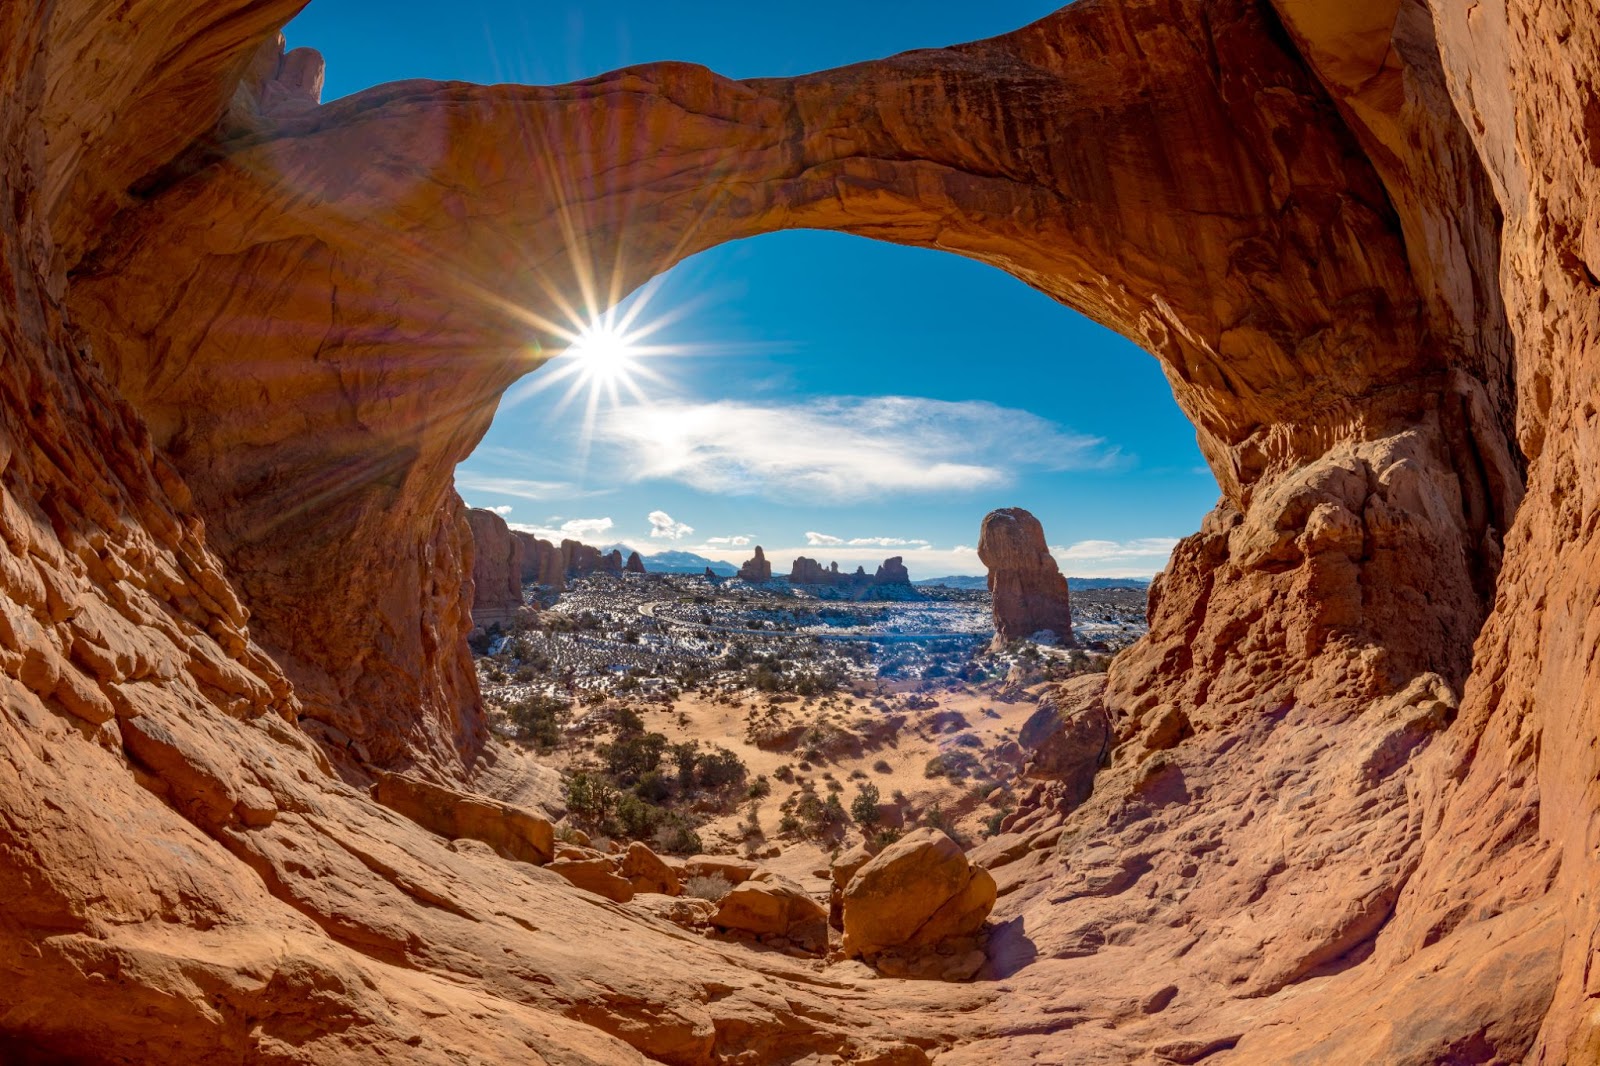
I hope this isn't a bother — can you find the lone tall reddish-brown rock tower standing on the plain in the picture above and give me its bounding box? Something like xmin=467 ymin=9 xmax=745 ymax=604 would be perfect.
xmin=978 ymin=507 xmax=1072 ymax=647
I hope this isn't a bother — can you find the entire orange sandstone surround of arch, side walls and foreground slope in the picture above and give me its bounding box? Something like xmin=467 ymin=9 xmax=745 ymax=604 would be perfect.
xmin=0 ymin=0 xmax=1600 ymax=1064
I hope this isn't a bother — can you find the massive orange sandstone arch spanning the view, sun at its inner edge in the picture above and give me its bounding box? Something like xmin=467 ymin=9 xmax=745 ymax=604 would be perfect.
xmin=70 ymin=0 xmax=1520 ymax=765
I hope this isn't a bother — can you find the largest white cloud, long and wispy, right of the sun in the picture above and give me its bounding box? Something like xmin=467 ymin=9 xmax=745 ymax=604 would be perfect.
xmin=597 ymin=397 xmax=1117 ymax=503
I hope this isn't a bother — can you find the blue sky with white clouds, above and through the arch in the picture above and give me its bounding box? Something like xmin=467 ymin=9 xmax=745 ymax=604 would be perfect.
xmin=286 ymin=0 xmax=1218 ymax=578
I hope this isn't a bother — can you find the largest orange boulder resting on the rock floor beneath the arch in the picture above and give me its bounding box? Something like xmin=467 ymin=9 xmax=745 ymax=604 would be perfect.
xmin=843 ymin=829 xmax=995 ymax=957
